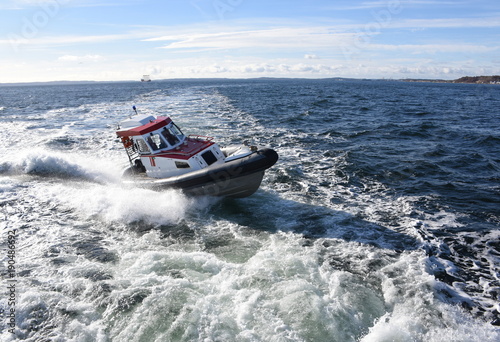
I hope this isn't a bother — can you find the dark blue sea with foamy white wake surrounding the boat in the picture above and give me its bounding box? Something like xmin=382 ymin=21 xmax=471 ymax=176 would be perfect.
xmin=0 ymin=79 xmax=500 ymax=342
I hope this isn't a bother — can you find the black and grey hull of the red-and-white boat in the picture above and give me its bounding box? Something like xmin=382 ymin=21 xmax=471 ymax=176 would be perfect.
xmin=124 ymin=149 xmax=278 ymax=198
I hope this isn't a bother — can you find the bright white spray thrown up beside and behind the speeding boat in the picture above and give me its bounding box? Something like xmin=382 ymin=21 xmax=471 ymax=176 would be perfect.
xmin=0 ymin=149 xmax=213 ymax=225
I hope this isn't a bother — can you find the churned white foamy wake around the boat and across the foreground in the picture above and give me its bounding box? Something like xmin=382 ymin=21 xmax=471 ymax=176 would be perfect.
xmin=0 ymin=85 xmax=500 ymax=342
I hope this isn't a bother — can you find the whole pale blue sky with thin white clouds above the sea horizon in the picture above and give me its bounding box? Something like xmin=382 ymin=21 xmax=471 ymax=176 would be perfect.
xmin=0 ymin=0 xmax=500 ymax=83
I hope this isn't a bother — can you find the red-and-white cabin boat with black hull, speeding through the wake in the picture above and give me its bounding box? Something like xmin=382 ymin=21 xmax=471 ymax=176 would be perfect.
xmin=116 ymin=106 xmax=278 ymax=198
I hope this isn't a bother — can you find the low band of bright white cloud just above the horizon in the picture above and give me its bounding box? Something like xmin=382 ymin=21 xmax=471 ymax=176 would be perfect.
xmin=0 ymin=54 xmax=500 ymax=82
